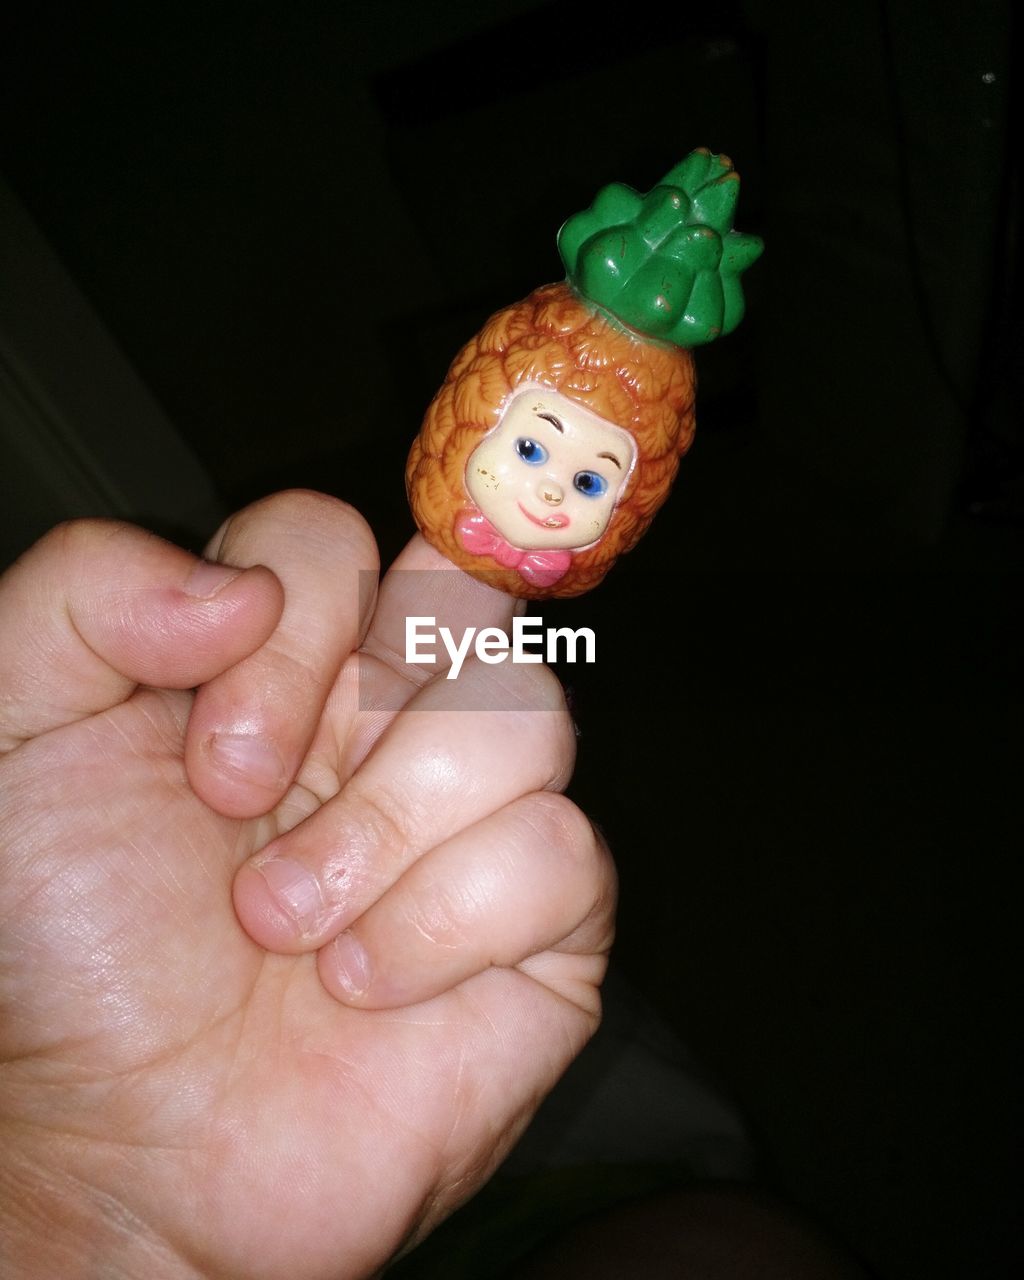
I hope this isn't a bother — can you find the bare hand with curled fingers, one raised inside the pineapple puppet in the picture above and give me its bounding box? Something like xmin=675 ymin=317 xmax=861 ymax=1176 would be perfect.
xmin=0 ymin=483 xmax=614 ymax=1280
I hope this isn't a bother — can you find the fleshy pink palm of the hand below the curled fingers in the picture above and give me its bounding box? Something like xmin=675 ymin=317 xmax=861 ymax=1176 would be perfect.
xmin=3 ymin=675 xmax=591 ymax=1277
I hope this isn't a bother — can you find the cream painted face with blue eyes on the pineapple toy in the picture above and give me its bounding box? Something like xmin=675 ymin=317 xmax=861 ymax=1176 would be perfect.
xmin=466 ymin=388 xmax=636 ymax=550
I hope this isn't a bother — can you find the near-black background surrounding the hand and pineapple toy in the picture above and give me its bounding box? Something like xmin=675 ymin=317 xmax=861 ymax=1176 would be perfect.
xmin=0 ymin=0 xmax=1024 ymax=1280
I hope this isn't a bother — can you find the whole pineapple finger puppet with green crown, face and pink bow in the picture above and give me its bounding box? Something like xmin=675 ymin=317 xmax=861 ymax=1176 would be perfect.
xmin=406 ymin=148 xmax=763 ymax=599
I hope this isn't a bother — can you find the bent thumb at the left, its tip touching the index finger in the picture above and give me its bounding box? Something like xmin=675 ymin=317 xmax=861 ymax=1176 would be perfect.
xmin=0 ymin=520 xmax=283 ymax=751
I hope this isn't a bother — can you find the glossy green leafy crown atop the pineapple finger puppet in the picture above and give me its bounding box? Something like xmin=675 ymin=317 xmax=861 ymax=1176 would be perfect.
xmin=558 ymin=147 xmax=764 ymax=347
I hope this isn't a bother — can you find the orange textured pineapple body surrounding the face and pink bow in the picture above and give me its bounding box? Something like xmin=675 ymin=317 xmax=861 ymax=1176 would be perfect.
xmin=406 ymin=284 xmax=695 ymax=599
